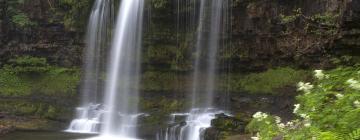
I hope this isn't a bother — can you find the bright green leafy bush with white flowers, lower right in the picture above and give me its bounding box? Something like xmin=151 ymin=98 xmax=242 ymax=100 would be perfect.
xmin=248 ymin=67 xmax=360 ymax=140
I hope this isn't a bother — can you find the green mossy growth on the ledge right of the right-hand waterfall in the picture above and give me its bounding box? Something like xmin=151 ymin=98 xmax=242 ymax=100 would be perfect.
xmin=220 ymin=67 xmax=309 ymax=94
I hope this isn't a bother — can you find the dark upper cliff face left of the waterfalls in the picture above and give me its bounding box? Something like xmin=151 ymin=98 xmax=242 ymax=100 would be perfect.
xmin=0 ymin=0 xmax=89 ymax=67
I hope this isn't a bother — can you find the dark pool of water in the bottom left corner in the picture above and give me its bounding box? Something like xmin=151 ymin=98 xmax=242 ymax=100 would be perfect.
xmin=0 ymin=131 xmax=95 ymax=140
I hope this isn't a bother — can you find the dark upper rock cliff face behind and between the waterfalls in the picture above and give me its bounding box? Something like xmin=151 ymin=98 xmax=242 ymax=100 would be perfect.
xmin=0 ymin=0 xmax=359 ymax=71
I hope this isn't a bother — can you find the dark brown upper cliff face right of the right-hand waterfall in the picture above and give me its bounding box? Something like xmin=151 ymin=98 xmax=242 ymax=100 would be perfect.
xmin=232 ymin=0 xmax=358 ymax=69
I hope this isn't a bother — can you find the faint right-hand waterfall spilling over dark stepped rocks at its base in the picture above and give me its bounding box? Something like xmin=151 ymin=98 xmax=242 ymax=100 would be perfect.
xmin=157 ymin=0 xmax=227 ymax=140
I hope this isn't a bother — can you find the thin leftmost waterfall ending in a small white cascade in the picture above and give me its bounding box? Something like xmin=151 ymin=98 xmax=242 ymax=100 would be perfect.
xmin=66 ymin=0 xmax=112 ymax=133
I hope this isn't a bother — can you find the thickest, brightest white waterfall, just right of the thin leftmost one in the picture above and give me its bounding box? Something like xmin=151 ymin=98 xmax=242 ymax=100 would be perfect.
xmin=88 ymin=0 xmax=144 ymax=140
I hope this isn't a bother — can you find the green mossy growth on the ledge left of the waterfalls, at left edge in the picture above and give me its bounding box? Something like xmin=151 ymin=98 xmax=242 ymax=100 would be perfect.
xmin=0 ymin=56 xmax=80 ymax=96
